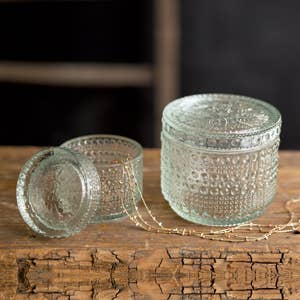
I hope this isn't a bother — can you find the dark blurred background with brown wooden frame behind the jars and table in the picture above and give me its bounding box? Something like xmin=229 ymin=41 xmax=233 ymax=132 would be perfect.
xmin=0 ymin=0 xmax=300 ymax=149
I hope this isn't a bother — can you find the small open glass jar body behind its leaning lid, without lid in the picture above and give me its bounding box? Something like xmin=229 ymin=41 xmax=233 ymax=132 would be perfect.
xmin=62 ymin=135 xmax=143 ymax=223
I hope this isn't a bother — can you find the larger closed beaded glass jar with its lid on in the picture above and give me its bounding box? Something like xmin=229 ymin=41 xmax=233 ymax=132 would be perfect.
xmin=161 ymin=94 xmax=281 ymax=226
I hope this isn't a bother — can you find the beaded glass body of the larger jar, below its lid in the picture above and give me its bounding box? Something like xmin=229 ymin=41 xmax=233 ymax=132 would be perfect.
xmin=161 ymin=131 xmax=279 ymax=226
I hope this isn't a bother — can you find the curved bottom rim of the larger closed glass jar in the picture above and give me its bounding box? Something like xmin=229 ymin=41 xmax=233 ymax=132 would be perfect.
xmin=169 ymin=201 xmax=265 ymax=226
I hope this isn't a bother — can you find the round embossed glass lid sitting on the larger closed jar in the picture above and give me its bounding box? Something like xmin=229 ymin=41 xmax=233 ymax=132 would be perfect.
xmin=163 ymin=94 xmax=281 ymax=150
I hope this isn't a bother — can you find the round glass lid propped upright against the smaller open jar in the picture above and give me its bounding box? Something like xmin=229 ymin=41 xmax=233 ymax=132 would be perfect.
xmin=17 ymin=148 xmax=101 ymax=237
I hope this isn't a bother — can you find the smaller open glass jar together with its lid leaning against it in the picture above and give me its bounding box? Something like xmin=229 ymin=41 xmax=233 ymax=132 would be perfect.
xmin=17 ymin=135 xmax=143 ymax=237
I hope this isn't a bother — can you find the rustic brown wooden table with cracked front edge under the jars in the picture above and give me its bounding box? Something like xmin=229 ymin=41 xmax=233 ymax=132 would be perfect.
xmin=0 ymin=147 xmax=300 ymax=300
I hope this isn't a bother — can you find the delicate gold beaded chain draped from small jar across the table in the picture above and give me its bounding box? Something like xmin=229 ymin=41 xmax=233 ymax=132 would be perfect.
xmin=122 ymin=159 xmax=300 ymax=242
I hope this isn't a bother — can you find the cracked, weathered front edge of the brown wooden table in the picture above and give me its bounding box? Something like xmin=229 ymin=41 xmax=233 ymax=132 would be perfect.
xmin=0 ymin=248 xmax=300 ymax=299
